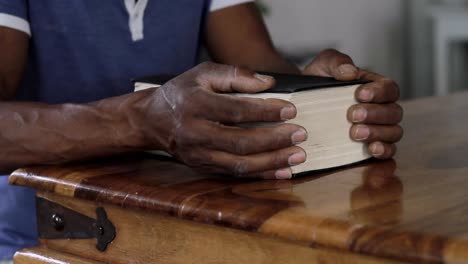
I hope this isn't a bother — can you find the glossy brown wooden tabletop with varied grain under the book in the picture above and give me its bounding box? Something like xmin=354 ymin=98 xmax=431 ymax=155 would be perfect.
xmin=10 ymin=90 xmax=468 ymax=263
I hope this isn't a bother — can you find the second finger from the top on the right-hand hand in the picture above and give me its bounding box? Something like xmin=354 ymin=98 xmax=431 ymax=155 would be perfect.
xmin=347 ymin=104 xmax=403 ymax=125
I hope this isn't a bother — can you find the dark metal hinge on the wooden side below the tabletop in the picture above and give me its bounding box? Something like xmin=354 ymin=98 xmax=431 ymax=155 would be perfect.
xmin=36 ymin=197 xmax=116 ymax=251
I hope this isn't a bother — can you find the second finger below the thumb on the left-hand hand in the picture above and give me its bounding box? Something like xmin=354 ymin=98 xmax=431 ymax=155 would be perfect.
xmin=185 ymin=122 xmax=307 ymax=156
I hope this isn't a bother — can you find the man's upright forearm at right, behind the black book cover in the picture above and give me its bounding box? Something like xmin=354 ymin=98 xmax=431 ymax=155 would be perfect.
xmin=205 ymin=3 xmax=300 ymax=74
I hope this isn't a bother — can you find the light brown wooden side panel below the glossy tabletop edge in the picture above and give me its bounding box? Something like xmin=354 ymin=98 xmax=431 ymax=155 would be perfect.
xmin=38 ymin=192 xmax=402 ymax=264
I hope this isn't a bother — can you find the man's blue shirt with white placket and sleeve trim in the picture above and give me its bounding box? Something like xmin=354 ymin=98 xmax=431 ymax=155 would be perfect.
xmin=0 ymin=0 xmax=256 ymax=259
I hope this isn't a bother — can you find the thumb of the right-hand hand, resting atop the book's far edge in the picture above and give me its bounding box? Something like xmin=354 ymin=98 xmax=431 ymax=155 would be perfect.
xmin=304 ymin=49 xmax=359 ymax=81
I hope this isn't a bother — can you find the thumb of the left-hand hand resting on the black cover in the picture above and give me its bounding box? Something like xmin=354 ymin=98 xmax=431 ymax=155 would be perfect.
xmin=194 ymin=62 xmax=275 ymax=93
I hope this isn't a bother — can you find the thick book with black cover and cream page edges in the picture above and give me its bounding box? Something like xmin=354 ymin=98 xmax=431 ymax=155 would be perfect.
xmin=134 ymin=73 xmax=370 ymax=175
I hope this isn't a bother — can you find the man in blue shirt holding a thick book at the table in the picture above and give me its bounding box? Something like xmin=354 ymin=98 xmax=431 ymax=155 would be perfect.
xmin=0 ymin=0 xmax=402 ymax=259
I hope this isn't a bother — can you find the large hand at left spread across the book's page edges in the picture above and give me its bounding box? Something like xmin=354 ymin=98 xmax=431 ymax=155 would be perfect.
xmin=138 ymin=63 xmax=307 ymax=179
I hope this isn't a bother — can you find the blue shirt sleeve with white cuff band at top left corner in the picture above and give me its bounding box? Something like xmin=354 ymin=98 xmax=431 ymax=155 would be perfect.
xmin=0 ymin=0 xmax=31 ymax=36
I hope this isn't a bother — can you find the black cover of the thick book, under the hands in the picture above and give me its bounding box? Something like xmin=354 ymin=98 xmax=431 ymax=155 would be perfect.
xmin=134 ymin=72 xmax=370 ymax=93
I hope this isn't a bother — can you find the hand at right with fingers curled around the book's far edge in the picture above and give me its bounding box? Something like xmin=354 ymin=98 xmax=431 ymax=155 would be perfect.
xmin=303 ymin=49 xmax=403 ymax=159
